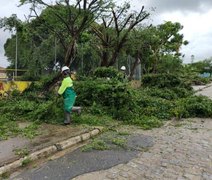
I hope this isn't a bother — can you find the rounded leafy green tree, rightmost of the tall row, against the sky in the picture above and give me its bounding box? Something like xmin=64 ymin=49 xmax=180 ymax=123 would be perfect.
xmin=127 ymin=22 xmax=188 ymax=78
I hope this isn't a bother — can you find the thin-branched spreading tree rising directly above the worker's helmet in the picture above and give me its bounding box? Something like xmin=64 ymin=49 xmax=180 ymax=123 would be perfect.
xmin=20 ymin=0 xmax=111 ymax=66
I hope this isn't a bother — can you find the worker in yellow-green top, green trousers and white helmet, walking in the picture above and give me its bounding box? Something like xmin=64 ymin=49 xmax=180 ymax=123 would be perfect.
xmin=58 ymin=66 xmax=76 ymax=125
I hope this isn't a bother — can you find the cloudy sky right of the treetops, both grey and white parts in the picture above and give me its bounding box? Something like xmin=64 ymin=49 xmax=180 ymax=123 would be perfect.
xmin=127 ymin=0 xmax=212 ymax=63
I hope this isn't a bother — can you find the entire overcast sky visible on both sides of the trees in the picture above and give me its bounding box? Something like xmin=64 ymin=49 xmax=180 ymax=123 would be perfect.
xmin=0 ymin=0 xmax=212 ymax=67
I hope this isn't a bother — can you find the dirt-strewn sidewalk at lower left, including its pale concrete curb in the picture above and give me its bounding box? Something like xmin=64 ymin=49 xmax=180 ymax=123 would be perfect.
xmin=0 ymin=123 xmax=101 ymax=175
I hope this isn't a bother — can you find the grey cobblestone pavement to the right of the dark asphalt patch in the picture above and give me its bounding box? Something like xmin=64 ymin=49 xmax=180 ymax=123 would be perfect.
xmin=74 ymin=119 xmax=212 ymax=180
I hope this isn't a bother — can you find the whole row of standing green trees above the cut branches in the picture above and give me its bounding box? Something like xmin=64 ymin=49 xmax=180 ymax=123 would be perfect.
xmin=0 ymin=0 xmax=188 ymax=80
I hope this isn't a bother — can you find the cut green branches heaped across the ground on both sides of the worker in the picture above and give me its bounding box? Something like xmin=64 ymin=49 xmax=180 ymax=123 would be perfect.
xmin=0 ymin=70 xmax=212 ymax=135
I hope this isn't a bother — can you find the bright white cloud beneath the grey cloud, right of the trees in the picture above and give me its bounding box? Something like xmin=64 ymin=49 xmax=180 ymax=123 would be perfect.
xmin=160 ymin=10 xmax=212 ymax=63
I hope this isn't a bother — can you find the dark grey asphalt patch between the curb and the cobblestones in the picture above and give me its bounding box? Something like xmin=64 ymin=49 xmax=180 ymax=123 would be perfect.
xmin=13 ymin=134 xmax=153 ymax=180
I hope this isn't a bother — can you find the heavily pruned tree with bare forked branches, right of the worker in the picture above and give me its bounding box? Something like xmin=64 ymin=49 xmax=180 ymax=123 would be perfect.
xmin=92 ymin=3 xmax=149 ymax=67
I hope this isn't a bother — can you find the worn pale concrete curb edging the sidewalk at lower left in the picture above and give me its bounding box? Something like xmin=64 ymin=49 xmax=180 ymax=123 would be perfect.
xmin=0 ymin=127 xmax=103 ymax=176
